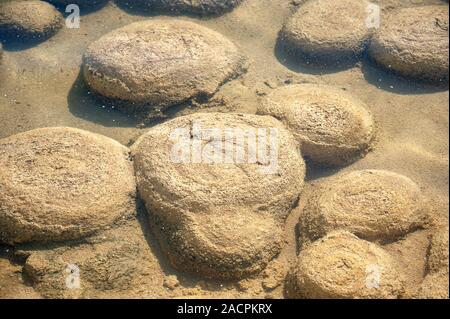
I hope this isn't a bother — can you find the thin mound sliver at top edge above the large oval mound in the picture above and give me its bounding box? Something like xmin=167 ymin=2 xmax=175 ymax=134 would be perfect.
xmin=121 ymin=0 xmax=243 ymax=15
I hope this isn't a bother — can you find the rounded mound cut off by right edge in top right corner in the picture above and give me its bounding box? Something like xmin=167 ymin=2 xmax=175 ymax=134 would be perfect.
xmin=369 ymin=5 xmax=449 ymax=82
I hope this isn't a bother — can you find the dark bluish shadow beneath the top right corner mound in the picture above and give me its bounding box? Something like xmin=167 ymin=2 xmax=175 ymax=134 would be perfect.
xmin=362 ymin=56 xmax=449 ymax=95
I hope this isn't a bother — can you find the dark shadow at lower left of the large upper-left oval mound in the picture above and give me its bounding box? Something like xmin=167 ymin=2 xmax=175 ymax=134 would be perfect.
xmin=67 ymin=72 xmax=143 ymax=127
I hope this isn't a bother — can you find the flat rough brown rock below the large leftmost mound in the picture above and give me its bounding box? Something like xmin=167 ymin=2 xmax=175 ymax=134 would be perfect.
xmin=23 ymin=218 xmax=165 ymax=298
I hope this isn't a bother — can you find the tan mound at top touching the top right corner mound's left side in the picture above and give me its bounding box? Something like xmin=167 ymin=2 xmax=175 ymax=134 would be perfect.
xmin=280 ymin=0 xmax=372 ymax=64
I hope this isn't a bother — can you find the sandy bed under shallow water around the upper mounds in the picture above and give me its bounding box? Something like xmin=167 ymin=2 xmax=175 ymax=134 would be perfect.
xmin=0 ymin=0 xmax=449 ymax=296
